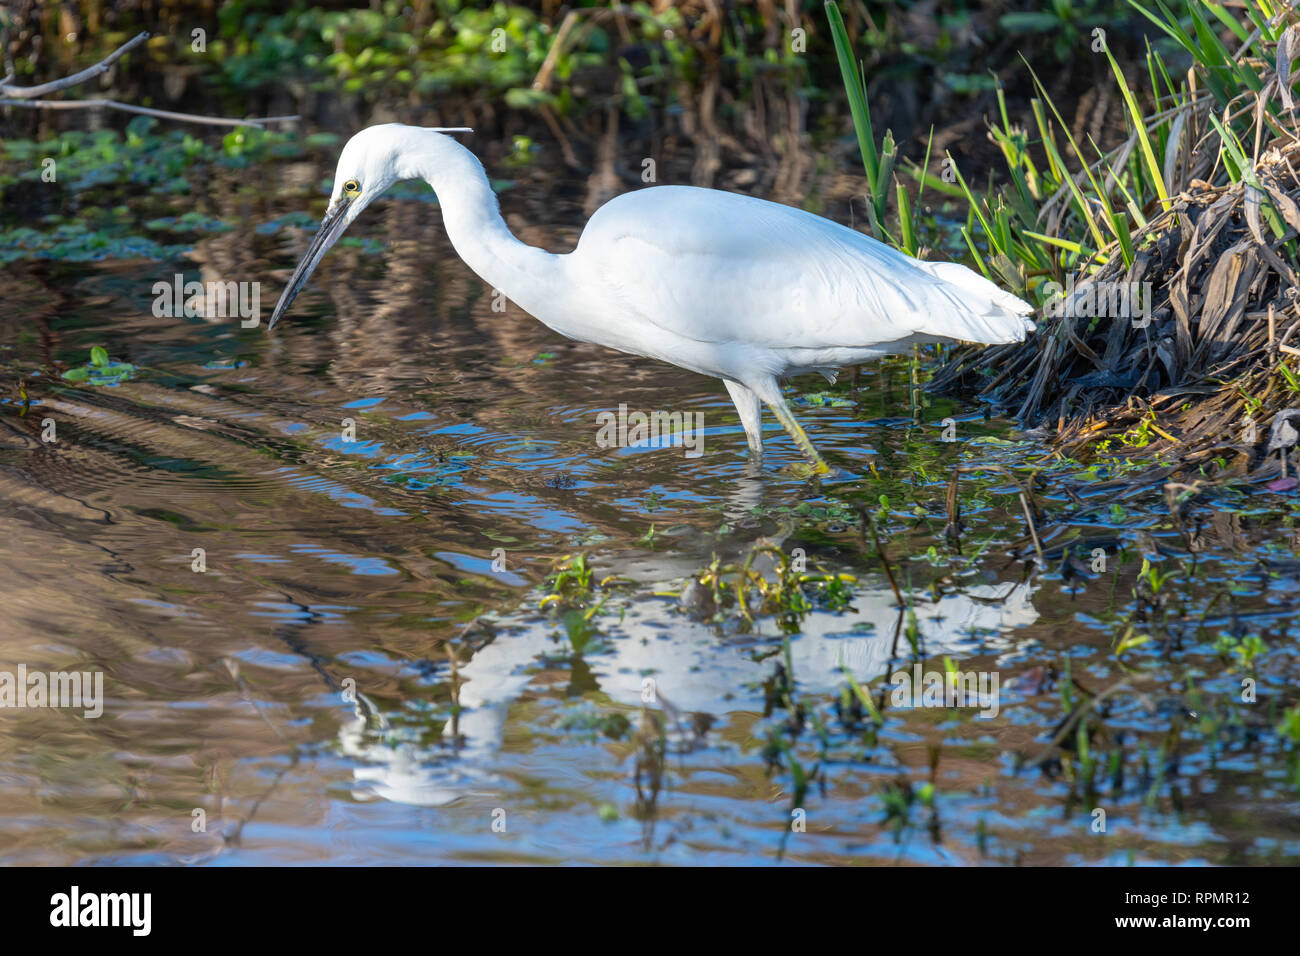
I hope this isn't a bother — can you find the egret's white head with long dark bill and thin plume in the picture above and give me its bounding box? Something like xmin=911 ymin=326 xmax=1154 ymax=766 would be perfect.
xmin=267 ymin=122 xmax=473 ymax=330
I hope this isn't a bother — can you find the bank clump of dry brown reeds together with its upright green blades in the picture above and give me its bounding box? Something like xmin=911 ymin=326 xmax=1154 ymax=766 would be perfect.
xmin=933 ymin=0 xmax=1300 ymax=475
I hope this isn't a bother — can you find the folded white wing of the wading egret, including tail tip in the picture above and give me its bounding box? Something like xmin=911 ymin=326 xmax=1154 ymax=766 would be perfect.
xmin=575 ymin=186 xmax=1034 ymax=349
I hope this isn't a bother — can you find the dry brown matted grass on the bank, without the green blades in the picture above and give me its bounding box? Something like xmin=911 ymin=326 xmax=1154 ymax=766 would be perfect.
xmin=932 ymin=5 xmax=1300 ymax=477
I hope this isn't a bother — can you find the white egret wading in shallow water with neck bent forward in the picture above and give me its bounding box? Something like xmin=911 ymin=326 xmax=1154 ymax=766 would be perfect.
xmin=270 ymin=124 xmax=1035 ymax=472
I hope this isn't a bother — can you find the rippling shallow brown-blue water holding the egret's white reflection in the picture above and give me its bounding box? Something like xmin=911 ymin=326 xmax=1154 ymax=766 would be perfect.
xmin=0 ymin=149 xmax=1300 ymax=865
